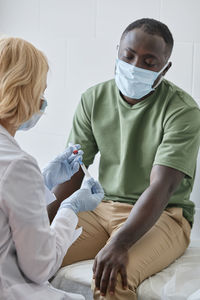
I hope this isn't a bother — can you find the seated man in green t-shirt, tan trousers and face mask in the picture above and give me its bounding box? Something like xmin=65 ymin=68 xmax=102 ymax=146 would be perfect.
xmin=49 ymin=19 xmax=200 ymax=300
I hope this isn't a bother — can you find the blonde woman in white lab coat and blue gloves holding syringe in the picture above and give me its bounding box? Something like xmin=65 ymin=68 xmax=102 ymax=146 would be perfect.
xmin=0 ymin=38 xmax=103 ymax=300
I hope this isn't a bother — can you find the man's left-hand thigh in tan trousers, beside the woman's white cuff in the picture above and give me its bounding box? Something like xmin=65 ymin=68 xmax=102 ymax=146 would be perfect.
xmin=62 ymin=203 xmax=109 ymax=267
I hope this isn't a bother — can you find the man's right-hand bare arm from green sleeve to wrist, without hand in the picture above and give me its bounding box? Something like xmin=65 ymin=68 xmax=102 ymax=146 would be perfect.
xmin=108 ymin=165 xmax=185 ymax=249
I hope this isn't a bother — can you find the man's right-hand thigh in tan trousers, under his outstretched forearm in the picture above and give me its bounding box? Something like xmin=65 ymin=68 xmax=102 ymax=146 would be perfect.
xmin=115 ymin=207 xmax=191 ymax=289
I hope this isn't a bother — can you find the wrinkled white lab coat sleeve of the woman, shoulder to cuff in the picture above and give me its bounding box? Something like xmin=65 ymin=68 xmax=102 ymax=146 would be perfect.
xmin=1 ymin=157 xmax=78 ymax=283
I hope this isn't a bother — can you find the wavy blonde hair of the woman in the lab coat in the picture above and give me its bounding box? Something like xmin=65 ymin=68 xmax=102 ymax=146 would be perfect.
xmin=0 ymin=38 xmax=49 ymax=127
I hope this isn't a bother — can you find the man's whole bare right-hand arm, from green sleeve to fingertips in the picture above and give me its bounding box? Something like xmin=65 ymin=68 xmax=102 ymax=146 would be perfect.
xmin=93 ymin=165 xmax=184 ymax=295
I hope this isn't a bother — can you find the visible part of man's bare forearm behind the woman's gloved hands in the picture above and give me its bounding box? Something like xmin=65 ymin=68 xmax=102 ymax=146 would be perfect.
xmin=47 ymin=169 xmax=84 ymax=222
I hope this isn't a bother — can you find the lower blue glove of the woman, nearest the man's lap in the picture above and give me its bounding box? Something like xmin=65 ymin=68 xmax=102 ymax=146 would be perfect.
xmin=59 ymin=178 xmax=104 ymax=214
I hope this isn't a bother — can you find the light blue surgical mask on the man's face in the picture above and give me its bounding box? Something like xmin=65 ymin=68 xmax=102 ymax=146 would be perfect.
xmin=115 ymin=58 xmax=168 ymax=100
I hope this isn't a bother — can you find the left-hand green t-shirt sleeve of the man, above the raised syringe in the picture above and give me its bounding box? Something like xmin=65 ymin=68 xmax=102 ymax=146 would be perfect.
xmin=67 ymin=94 xmax=98 ymax=166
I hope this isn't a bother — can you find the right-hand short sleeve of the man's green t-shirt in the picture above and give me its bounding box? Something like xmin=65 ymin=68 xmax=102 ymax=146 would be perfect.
xmin=153 ymin=107 xmax=200 ymax=178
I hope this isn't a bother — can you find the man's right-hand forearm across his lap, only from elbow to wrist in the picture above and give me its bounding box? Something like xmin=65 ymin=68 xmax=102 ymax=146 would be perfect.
xmin=111 ymin=184 xmax=170 ymax=249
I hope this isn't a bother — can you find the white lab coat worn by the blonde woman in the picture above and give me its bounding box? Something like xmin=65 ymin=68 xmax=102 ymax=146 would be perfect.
xmin=0 ymin=126 xmax=84 ymax=300
